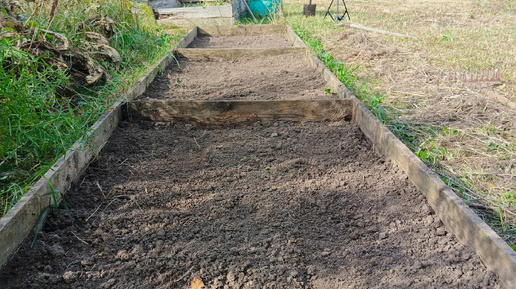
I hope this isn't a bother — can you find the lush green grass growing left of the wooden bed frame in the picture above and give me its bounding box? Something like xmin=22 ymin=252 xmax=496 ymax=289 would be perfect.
xmin=0 ymin=0 xmax=179 ymax=216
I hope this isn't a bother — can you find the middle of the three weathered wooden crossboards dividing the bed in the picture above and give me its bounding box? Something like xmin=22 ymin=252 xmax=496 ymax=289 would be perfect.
xmin=176 ymin=48 xmax=307 ymax=60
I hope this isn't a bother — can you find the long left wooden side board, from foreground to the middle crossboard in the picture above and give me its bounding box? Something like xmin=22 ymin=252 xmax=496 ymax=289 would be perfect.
xmin=0 ymin=44 xmax=173 ymax=268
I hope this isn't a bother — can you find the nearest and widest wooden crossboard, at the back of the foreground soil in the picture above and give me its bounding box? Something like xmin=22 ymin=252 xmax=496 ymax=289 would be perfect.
xmin=127 ymin=99 xmax=353 ymax=127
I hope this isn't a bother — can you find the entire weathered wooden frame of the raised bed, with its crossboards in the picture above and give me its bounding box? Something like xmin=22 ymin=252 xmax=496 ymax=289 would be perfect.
xmin=0 ymin=25 xmax=516 ymax=288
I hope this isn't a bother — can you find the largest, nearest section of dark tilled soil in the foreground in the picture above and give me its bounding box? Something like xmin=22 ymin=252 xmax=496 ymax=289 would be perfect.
xmin=0 ymin=121 xmax=498 ymax=288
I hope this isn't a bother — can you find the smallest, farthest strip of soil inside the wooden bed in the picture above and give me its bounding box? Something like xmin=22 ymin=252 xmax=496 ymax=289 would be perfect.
xmin=187 ymin=34 xmax=293 ymax=48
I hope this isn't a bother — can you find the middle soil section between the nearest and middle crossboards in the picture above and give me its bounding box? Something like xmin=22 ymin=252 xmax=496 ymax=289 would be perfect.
xmin=140 ymin=54 xmax=335 ymax=100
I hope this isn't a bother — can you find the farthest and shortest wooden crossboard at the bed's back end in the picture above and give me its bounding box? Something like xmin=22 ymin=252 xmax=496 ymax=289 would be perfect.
xmin=198 ymin=24 xmax=288 ymax=37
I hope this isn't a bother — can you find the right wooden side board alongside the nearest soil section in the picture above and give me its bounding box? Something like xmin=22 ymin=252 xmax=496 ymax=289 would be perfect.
xmin=354 ymin=98 xmax=516 ymax=288
